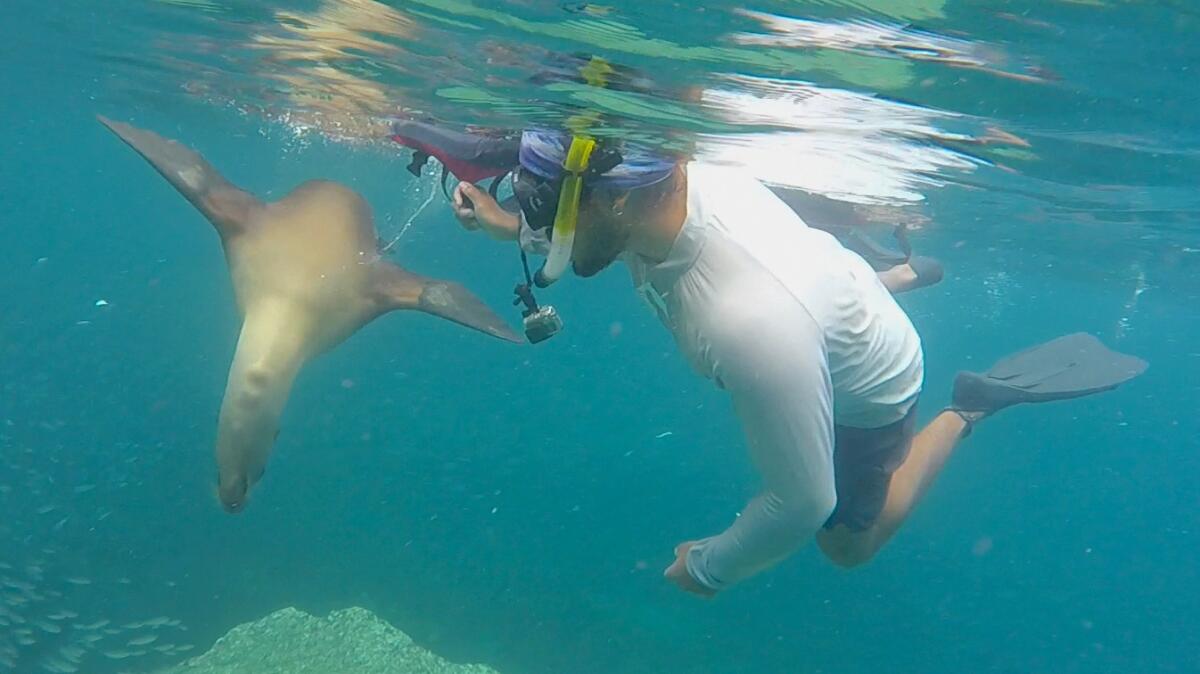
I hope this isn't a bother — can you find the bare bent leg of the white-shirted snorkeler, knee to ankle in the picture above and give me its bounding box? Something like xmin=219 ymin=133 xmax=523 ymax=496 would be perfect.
xmin=817 ymin=411 xmax=967 ymax=567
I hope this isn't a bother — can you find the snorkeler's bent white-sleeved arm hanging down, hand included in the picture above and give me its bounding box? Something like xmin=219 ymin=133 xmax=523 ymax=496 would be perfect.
xmin=686 ymin=305 xmax=836 ymax=590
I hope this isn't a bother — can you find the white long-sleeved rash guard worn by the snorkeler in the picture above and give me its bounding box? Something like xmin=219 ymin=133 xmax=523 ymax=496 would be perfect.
xmin=521 ymin=162 xmax=924 ymax=589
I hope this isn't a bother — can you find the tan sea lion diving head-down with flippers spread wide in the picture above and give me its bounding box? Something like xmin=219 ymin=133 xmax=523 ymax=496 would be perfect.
xmin=100 ymin=116 xmax=520 ymax=512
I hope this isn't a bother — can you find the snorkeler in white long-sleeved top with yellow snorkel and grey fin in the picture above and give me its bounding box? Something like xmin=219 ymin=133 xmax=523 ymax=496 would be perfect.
xmin=441 ymin=131 xmax=1146 ymax=596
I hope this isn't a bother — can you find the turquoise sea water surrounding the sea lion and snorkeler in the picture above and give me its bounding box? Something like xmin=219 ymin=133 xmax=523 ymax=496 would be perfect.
xmin=0 ymin=0 xmax=1200 ymax=674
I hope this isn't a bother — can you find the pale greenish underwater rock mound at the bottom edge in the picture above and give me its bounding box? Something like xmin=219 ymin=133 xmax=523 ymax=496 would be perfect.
xmin=157 ymin=607 xmax=498 ymax=674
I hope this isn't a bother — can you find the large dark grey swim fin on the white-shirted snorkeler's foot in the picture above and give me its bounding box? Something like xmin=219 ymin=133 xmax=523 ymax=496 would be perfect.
xmin=952 ymin=332 xmax=1147 ymax=415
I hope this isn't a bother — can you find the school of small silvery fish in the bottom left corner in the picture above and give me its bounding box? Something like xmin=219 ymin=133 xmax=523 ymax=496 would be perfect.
xmin=0 ymin=443 xmax=193 ymax=674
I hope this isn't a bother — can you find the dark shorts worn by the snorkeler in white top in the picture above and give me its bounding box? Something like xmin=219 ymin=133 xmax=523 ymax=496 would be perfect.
xmin=824 ymin=402 xmax=917 ymax=531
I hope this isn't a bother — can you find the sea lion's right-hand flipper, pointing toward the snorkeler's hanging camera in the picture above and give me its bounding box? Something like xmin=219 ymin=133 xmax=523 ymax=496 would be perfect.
xmin=373 ymin=261 xmax=521 ymax=343
